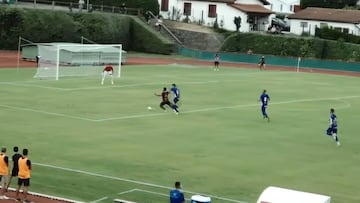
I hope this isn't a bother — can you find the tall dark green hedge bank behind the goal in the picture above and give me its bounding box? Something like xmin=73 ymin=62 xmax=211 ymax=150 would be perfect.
xmin=0 ymin=7 xmax=174 ymax=54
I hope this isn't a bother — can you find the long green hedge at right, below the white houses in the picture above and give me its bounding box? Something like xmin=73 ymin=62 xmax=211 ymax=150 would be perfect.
xmin=221 ymin=33 xmax=360 ymax=61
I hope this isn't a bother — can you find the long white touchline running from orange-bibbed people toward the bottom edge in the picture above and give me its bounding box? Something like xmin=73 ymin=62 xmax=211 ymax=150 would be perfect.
xmin=33 ymin=163 xmax=248 ymax=203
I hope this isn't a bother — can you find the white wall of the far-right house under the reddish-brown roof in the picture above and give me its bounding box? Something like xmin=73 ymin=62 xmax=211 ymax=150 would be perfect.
xmin=290 ymin=19 xmax=360 ymax=36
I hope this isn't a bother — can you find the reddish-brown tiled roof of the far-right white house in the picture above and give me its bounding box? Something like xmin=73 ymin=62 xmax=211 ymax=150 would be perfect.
xmin=288 ymin=7 xmax=360 ymax=23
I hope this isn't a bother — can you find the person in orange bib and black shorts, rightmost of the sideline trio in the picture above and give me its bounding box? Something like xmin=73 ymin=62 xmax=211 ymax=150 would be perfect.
xmin=16 ymin=149 xmax=31 ymax=203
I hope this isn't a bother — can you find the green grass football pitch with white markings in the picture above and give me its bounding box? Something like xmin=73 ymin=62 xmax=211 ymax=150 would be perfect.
xmin=0 ymin=65 xmax=360 ymax=203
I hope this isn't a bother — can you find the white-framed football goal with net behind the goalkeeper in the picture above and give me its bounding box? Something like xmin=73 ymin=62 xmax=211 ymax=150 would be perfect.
xmin=34 ymin=43 xmax=122 ymax=80
